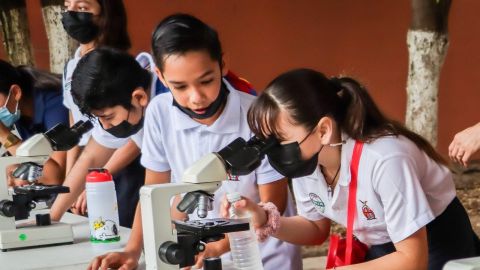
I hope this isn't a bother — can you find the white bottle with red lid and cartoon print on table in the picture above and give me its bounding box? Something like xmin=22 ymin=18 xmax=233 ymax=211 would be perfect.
xmin=85 ymin=169 xmax=120 ymax=250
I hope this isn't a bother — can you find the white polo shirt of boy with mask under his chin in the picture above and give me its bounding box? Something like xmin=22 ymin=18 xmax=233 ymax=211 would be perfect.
xmin=141 ymin=80 xmax=302 ymax=270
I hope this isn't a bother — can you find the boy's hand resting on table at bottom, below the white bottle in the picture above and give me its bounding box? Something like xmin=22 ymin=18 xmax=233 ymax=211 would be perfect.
xmin=87 ymin=251 xmax=140 ymax=270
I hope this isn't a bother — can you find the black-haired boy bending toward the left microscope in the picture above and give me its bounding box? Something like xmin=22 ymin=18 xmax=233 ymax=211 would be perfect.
xmin=51 ymin=48 xmax=153 ymax=227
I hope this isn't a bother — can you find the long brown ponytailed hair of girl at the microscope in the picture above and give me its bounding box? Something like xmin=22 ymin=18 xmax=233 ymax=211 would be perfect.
xmin=248 ymin=69 xmax=446 ymax=164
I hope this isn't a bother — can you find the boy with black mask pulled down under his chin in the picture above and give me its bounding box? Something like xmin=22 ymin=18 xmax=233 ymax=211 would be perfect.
xmin=89 ymin=14 xmax=302 ymax=270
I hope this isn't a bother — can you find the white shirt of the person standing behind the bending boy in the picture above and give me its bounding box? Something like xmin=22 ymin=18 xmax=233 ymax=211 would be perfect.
xmin=62 ymin=47 xmax=92 ymax=146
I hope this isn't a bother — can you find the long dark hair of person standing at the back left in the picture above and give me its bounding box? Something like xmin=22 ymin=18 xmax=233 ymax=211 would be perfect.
xmin=96 ymin=0 xmax=131 ymax=51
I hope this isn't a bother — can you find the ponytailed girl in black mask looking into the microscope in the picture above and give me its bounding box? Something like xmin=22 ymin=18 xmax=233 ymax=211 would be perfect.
xmin=223 ymin=69 xmax=480 ymax=270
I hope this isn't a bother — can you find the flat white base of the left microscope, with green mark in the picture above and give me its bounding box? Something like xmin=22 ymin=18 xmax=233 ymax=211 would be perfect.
xmin=0 ymin=223 xmax=73 ymax=251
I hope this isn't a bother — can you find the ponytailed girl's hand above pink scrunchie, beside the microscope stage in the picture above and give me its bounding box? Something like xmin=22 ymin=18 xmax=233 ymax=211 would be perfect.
xmin=220 ymin=195 xmax=268 ymax=229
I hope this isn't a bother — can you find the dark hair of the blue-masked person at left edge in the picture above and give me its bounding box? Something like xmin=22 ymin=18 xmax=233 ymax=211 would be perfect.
xmin=0 ymin=59 xmax=33 ymax=96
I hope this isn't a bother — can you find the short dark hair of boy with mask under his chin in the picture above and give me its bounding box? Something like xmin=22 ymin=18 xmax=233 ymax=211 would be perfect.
xmin=152 ymin=13 xmax=223 ymax=71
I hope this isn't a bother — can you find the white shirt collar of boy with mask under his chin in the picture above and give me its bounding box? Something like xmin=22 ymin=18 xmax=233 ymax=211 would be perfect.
xmin=172 ymin=79 xmax=241 ymax=134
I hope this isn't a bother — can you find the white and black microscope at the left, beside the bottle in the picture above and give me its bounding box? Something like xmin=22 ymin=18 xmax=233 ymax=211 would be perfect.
xmin=0 ymin=121 xmax=93 ymax=251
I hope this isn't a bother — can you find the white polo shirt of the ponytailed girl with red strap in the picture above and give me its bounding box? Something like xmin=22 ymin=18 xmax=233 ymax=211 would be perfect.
xmin=293 ymin=136 xmax=456 ymax=245
